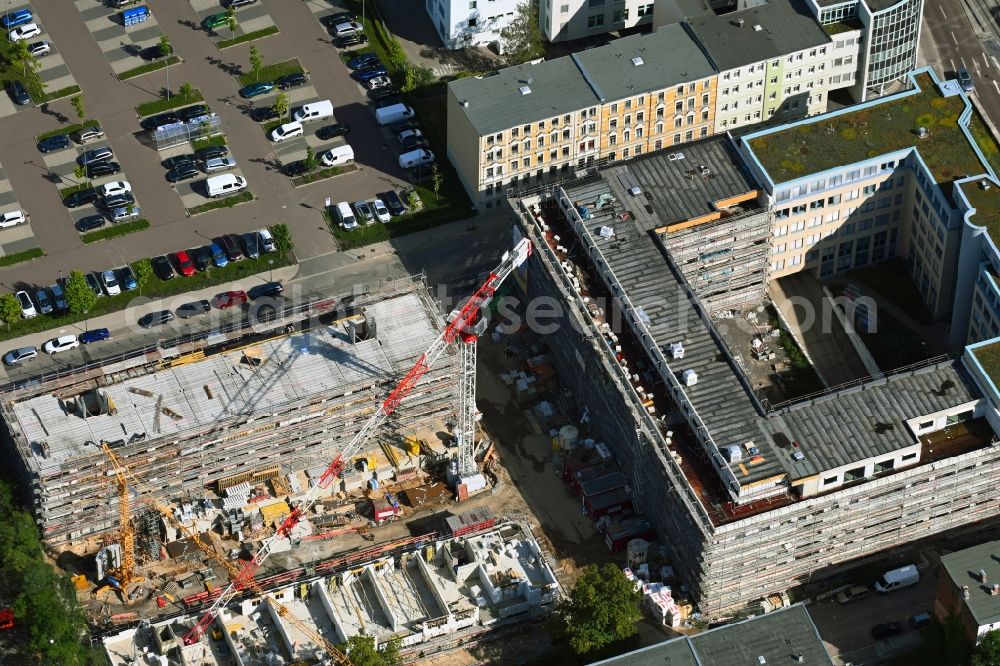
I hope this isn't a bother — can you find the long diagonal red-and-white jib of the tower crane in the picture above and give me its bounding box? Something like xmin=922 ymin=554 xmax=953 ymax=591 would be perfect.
xmin=184 ymin=238 xmax=531 ymax=645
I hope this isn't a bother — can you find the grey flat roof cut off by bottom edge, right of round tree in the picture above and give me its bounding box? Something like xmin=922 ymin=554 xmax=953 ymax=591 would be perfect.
xmin=594 ymin=603 xmax=833 ymax=666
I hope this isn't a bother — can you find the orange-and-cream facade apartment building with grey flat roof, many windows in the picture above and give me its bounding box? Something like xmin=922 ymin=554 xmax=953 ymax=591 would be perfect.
xmin=447 ymin=25 xmax=716 ymax=209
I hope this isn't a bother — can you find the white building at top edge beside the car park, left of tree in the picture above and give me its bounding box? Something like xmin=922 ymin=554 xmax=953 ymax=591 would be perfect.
xmin=425 ymin=0 xmax=528 ymax=49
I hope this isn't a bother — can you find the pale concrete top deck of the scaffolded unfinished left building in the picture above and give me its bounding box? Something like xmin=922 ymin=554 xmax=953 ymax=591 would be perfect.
xmin=11 ymin=294 xmax=438 ymax=476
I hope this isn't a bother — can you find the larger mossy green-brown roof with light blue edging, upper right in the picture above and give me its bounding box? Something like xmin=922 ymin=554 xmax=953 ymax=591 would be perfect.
xmin=747 ymin=73 xmax=986 ymax=183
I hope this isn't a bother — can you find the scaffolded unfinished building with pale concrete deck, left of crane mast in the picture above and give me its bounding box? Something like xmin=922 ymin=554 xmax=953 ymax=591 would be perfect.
xmin=0 ymin=282 xmax=456 ymax=547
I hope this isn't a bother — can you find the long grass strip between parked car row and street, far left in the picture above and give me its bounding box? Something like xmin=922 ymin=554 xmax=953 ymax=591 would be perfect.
xmin=0 ymin=253 xmax=295 ymax=340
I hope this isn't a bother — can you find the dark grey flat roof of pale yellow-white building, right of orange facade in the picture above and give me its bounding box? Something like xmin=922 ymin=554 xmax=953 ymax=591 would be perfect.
xmin=688 ymin=0 xmax=831 ymax=71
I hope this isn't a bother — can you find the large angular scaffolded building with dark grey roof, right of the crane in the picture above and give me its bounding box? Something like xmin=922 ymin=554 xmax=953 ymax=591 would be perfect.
xmin=512 ymin=138 xmax=1000 ymax=617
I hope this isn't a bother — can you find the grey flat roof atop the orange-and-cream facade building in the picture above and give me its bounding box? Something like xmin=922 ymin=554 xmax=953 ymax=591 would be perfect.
xmin=448 ymin=24 xmax=715 ymax=135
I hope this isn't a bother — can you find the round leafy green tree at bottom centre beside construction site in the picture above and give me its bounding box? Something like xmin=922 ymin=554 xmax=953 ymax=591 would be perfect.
xmin=555 ymin=562 xmax=642 ymax=654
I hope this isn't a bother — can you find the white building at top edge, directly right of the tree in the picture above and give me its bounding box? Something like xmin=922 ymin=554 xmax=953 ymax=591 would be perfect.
xmin=538 ymin=0 xmax=653 ymax=42
